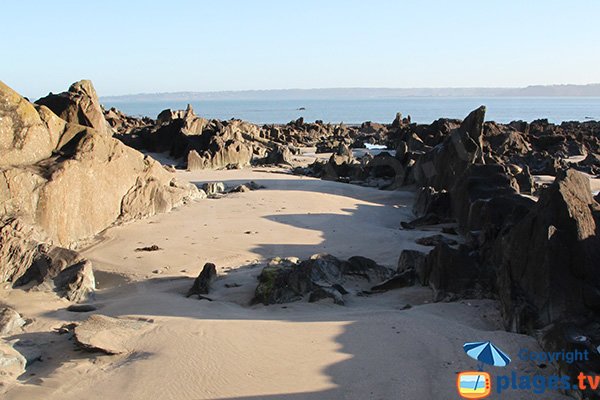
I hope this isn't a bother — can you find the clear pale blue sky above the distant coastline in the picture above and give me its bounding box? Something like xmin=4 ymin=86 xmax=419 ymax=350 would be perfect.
xmin=0 ymin=0 xmax=600 ymax=98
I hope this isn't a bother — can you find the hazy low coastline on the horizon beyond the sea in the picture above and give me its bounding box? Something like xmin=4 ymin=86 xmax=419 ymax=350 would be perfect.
xmin=100 ymin=83 xmax=600 ymax=102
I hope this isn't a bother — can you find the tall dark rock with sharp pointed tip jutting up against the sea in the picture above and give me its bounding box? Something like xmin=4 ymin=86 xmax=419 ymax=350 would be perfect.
xmin=413 ymin=106 xmax=485 ymax=191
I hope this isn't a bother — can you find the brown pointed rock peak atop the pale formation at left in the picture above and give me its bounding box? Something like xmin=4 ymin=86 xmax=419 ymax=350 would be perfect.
xmin=36 ymin=80 xmax=112 ymax=136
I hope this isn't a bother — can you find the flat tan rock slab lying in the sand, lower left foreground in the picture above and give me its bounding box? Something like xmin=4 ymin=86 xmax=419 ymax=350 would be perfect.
xmin=73 ymin=314 xmax=150 ymax=354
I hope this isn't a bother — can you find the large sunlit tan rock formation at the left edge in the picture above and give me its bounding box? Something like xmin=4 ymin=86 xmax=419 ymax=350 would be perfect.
xmin=0 ymin=79 xmax=197 ymax=247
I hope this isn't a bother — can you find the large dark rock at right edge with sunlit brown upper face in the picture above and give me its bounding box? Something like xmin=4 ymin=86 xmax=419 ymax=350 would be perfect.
xmin=495 ymin=170 xmax=600 ymax=332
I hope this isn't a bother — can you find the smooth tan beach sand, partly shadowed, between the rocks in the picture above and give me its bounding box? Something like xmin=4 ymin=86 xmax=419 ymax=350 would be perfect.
xmin=0 ymin=161 xmax=563 ymax=400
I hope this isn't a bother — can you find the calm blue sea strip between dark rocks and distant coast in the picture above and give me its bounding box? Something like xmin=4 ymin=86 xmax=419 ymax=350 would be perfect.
xmin=104 ymin=97 xmax=600 ymax=124
